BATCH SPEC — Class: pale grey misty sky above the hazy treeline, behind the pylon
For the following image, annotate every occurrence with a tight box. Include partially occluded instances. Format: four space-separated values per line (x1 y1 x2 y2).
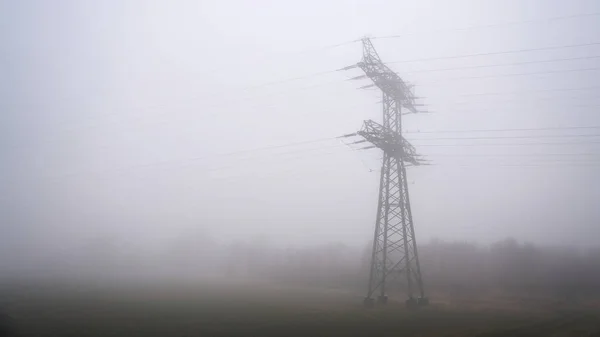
0 0 600 264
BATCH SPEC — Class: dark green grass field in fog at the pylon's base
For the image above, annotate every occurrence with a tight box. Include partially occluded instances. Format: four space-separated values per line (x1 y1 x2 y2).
0 284 600 337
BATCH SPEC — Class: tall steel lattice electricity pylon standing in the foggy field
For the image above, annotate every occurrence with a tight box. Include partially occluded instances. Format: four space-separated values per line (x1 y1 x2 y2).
340 38 428 307
